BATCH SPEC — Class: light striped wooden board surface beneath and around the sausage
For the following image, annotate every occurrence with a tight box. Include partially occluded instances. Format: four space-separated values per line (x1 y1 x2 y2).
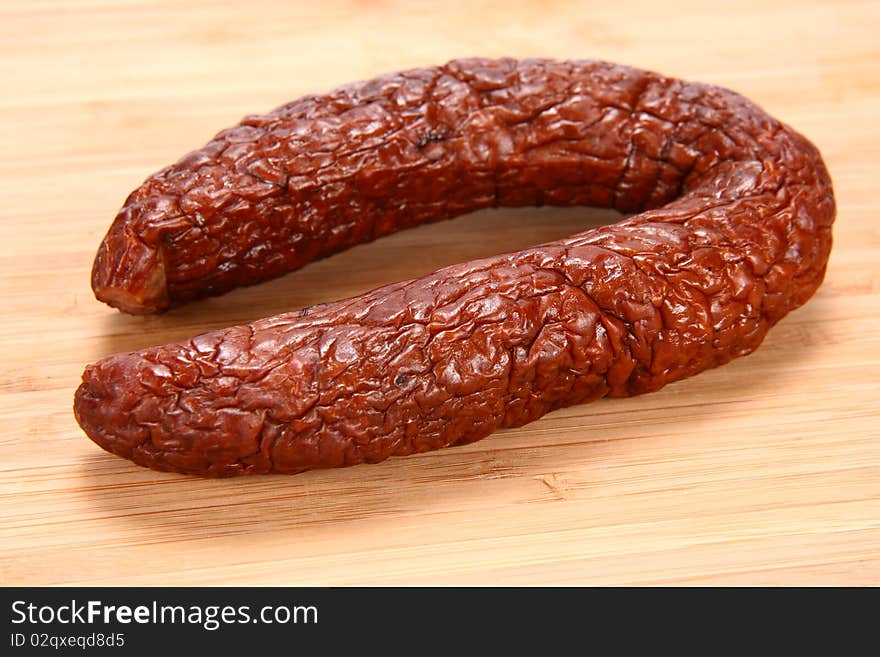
0 0 880 585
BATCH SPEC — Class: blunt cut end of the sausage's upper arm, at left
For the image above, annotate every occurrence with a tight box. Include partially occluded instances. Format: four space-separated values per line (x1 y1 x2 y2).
92 226 171 315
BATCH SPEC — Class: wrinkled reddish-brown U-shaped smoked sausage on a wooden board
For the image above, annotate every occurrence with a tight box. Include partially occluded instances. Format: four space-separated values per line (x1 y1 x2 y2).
75 60 835 475
